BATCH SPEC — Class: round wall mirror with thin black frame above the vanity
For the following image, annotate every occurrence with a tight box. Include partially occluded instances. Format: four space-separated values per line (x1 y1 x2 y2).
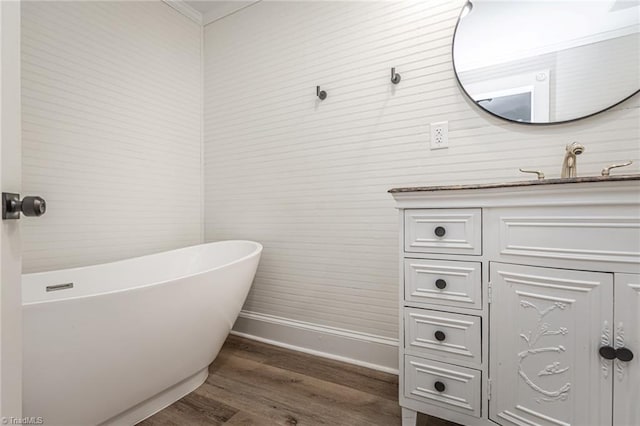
453 0 640 124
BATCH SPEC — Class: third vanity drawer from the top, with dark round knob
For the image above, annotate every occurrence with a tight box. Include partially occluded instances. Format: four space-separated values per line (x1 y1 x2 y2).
404 308 482 367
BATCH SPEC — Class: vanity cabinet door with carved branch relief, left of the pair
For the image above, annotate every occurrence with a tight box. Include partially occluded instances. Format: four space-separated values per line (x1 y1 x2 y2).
489 263 613 426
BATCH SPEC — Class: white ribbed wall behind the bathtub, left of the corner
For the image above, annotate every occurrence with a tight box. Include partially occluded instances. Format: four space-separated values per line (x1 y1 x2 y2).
22 1 202 272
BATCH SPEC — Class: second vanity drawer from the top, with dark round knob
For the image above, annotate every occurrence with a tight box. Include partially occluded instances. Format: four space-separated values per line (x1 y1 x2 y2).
404 259 482 309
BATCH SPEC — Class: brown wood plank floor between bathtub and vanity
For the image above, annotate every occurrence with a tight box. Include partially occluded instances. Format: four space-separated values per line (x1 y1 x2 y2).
139 336 455 426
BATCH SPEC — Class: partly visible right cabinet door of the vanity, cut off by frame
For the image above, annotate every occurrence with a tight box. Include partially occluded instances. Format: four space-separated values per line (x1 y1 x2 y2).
613 274 640 426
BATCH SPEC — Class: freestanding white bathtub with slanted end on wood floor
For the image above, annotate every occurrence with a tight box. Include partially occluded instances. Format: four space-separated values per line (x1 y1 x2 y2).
22 241 262 426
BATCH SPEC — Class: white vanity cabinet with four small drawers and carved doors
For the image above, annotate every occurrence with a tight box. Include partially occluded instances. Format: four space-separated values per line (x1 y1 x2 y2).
391 176 640 426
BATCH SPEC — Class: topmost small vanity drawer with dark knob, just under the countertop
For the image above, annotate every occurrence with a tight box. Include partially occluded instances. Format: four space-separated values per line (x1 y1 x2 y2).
404 209 482 255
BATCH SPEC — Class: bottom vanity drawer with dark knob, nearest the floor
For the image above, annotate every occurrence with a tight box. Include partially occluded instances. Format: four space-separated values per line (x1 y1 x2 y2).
404 355 482 417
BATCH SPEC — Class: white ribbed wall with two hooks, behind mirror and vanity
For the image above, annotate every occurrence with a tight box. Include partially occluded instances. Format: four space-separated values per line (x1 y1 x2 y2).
204 0 640 352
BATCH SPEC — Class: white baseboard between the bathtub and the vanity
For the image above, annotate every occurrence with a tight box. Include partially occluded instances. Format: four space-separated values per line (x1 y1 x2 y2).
231 311 398 374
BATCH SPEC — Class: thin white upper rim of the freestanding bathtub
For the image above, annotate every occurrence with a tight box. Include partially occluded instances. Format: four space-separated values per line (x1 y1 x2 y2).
20 240 264 309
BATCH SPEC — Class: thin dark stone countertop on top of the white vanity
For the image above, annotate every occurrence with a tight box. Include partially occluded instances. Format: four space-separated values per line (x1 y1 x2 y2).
388 174 640 194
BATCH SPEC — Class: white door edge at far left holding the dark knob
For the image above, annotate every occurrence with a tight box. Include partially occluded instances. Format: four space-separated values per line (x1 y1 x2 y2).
0 1 24 416
